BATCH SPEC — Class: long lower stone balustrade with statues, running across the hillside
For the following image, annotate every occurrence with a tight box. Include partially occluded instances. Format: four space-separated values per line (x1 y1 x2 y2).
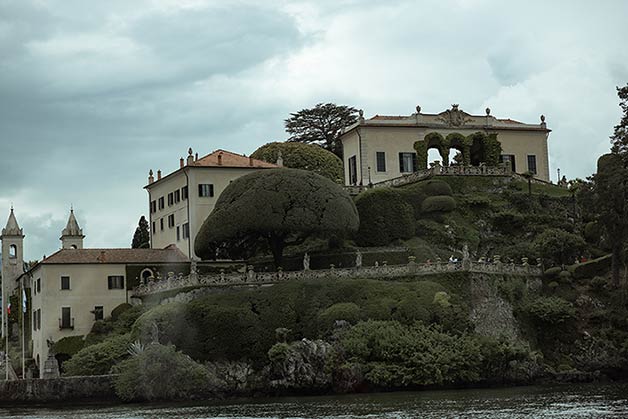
133 257 543 297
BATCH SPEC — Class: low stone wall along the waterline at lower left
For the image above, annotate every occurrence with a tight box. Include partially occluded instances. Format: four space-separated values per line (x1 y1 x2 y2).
0 375 118 404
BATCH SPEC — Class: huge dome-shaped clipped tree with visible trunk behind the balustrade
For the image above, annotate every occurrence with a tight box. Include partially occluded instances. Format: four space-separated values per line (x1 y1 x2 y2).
194 168 359 267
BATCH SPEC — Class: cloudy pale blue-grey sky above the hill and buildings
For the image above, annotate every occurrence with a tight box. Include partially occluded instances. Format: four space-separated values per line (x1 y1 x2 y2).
0 0 628 259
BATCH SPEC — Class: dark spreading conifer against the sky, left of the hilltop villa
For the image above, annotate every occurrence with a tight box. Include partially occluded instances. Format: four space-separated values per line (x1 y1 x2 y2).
284 103 358 158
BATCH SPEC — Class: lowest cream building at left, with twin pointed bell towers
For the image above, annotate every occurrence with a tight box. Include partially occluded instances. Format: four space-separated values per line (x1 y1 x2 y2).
2 211 190 375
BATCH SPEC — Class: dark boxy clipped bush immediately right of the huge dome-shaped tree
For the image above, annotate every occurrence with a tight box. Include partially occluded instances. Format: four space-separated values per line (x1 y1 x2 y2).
355 188 414 246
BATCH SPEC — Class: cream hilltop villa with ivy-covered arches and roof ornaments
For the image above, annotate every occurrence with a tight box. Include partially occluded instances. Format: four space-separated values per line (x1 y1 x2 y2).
341 105 550 185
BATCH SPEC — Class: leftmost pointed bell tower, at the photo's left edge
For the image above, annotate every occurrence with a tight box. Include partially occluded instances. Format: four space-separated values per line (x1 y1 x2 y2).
0 208 24 302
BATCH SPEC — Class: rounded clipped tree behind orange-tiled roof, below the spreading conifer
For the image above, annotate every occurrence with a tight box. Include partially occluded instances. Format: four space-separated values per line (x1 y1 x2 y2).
251 142 344 184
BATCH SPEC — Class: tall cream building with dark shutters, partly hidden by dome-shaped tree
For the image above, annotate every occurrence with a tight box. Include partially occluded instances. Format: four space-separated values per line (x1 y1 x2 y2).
145 149 277 258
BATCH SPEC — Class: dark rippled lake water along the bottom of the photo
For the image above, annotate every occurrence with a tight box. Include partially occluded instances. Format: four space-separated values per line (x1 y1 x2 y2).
0 384 628 419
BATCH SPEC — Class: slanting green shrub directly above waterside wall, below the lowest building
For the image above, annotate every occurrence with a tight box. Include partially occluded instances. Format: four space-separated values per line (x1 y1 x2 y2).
63 334 132 376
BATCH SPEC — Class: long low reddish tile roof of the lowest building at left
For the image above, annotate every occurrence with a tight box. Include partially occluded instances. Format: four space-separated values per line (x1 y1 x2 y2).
40 245 189 265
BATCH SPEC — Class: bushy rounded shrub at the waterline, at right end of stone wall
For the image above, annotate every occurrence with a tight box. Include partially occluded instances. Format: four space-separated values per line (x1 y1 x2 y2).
114 345 212 401
